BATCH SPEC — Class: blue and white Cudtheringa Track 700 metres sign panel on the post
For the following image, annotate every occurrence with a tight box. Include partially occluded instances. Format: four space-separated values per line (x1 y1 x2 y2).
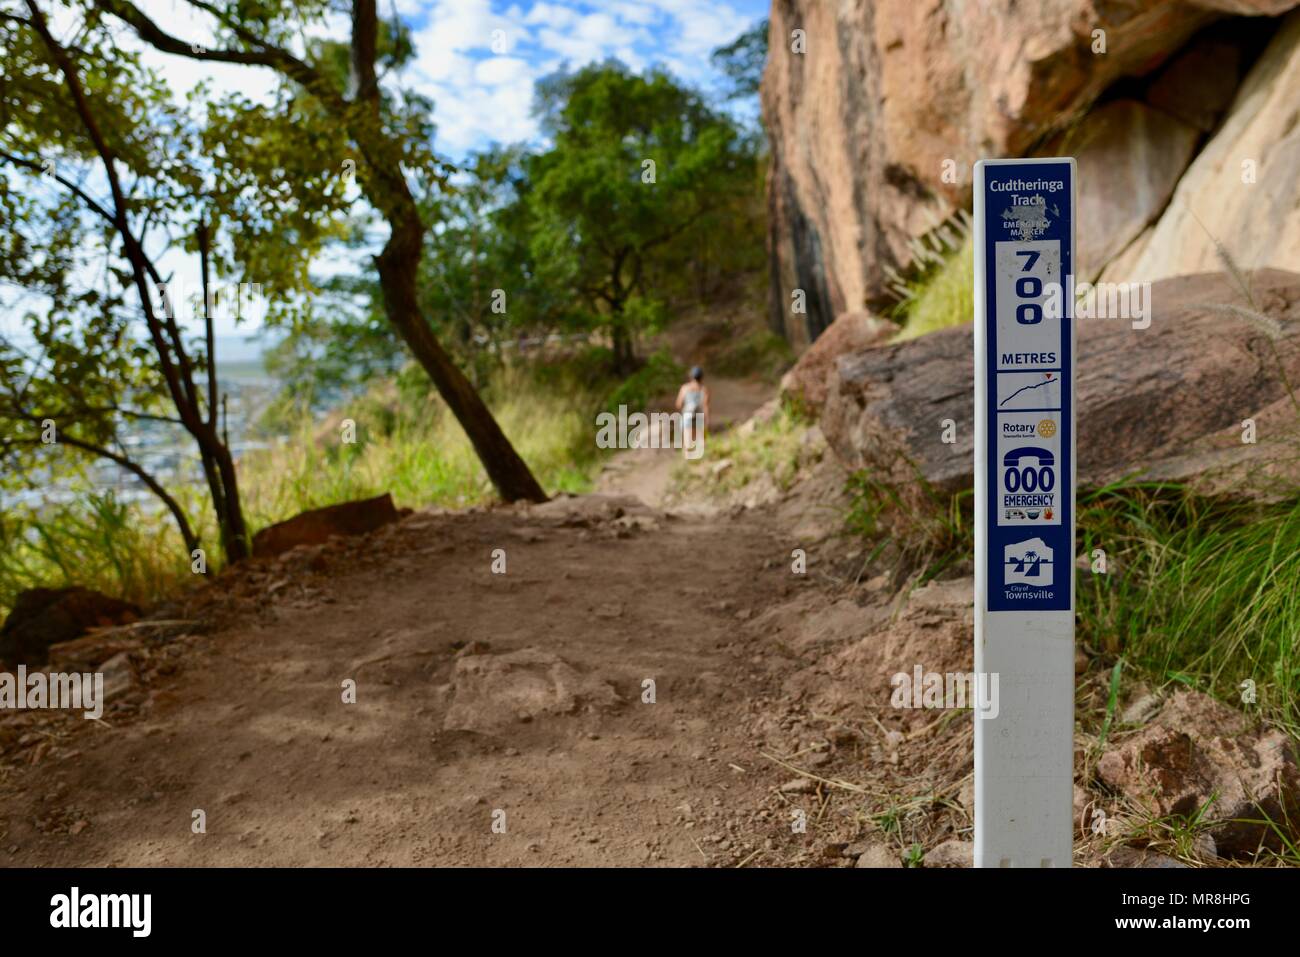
976 160 1074 611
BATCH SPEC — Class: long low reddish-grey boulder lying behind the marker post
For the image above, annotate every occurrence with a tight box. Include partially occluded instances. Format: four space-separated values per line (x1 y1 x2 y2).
822 270 1300 495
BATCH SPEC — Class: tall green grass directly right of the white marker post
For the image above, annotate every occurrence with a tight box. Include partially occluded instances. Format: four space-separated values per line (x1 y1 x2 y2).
1078 485 1300 733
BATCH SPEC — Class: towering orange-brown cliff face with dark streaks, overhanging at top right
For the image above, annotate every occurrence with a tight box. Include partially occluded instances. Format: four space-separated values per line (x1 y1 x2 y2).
762 0 1296 347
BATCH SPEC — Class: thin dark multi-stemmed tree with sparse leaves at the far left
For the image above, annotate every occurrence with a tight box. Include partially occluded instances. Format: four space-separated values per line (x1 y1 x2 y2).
0 0 287 560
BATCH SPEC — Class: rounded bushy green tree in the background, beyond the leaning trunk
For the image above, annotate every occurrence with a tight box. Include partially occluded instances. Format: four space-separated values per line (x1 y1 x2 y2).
528 61 755 373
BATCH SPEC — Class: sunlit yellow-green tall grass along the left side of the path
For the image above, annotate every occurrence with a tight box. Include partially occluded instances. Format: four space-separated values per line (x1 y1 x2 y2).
0 355 618 618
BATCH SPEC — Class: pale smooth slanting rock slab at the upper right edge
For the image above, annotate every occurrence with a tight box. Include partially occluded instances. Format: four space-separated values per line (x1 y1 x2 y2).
1123 13 1300 281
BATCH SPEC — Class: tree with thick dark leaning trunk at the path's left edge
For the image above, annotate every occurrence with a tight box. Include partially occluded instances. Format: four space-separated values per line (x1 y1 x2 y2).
91 0 546 501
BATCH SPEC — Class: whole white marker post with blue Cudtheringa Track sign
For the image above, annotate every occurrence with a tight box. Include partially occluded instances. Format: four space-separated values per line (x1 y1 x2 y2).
975 159 1075 867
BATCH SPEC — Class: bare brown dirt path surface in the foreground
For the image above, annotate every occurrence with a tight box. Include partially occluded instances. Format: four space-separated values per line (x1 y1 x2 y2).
0 486 826 866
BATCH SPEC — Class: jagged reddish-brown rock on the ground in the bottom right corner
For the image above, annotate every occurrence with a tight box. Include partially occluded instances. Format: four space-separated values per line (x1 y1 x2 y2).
1097 690 1300 857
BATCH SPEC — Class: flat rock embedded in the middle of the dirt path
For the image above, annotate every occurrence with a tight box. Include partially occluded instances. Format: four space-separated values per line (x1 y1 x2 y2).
443 648 621 733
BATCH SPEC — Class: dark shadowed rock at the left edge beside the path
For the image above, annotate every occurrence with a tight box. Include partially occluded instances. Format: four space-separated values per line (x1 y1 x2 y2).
0 585 140 666
